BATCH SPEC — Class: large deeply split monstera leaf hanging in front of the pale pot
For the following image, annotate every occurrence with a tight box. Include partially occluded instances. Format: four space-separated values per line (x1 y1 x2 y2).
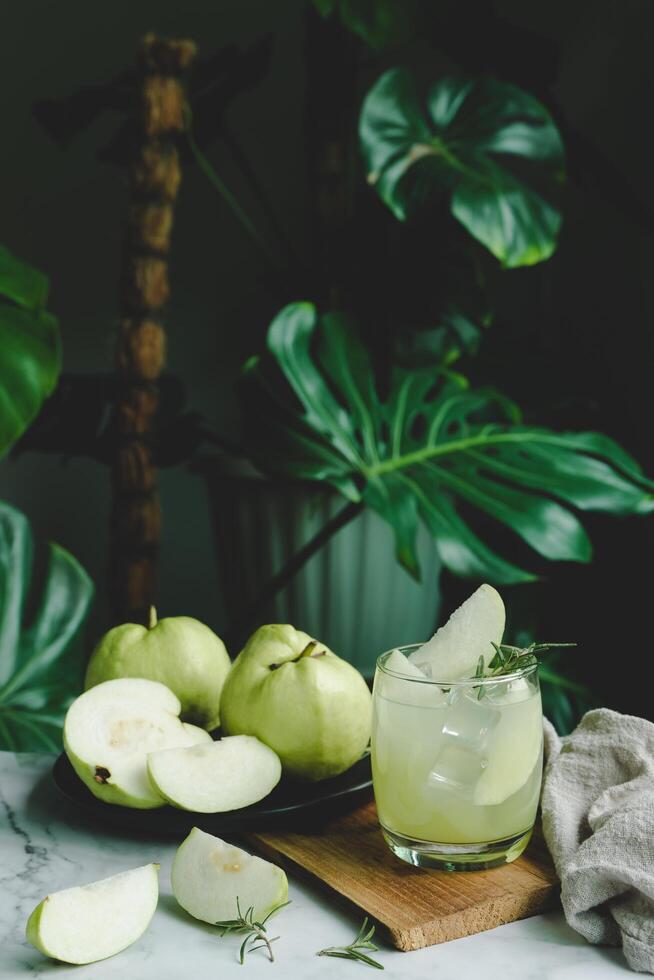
243 303 654 584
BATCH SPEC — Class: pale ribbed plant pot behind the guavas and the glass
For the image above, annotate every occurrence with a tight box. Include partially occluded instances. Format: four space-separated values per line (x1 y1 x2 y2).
197 457 441 675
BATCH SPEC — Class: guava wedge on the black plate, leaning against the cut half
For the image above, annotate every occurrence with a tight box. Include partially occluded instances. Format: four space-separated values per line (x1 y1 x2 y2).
148 735 282 813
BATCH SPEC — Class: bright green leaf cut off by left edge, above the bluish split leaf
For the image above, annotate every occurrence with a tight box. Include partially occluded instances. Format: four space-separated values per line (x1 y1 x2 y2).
0 246 61 456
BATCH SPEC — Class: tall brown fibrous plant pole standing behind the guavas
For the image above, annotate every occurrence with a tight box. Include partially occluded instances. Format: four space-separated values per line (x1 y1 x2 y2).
109 34 196 623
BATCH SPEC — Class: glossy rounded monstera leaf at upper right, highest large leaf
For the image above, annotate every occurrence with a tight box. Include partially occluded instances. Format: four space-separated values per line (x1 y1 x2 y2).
359 68 564 267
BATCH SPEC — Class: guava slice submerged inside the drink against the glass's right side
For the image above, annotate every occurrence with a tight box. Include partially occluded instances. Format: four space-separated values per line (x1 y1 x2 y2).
472 681 543 806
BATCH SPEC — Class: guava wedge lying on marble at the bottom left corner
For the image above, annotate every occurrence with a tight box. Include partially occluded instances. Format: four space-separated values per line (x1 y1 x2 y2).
26 864 159 964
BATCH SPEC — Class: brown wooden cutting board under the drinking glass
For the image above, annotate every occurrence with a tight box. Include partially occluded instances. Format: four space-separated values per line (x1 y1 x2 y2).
247 803 559 950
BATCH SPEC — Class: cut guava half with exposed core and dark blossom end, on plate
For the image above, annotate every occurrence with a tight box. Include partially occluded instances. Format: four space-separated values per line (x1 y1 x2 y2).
64 677 200 809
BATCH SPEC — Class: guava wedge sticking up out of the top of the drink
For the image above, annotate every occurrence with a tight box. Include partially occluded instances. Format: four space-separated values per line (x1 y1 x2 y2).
409 585 506 682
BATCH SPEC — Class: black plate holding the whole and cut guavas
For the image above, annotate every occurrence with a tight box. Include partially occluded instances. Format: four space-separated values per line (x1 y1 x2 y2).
52 752 372 837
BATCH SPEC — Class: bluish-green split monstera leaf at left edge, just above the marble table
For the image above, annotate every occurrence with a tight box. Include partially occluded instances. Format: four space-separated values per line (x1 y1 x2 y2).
0 503 93 752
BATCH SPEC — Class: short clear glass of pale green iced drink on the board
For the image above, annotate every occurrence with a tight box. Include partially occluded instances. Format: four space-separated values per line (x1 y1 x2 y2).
372 643 543 871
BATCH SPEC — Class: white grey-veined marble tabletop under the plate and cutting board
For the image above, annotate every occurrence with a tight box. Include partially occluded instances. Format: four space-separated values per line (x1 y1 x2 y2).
0 752 633 980
